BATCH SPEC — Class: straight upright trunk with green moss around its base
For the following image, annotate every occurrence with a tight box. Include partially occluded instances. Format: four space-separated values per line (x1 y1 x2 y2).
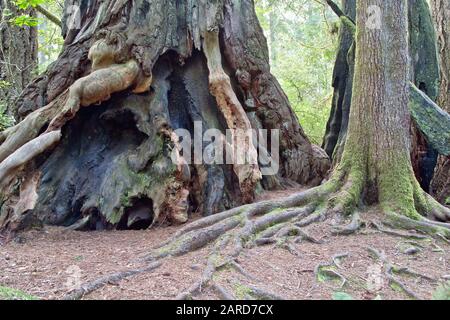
338 0 418 218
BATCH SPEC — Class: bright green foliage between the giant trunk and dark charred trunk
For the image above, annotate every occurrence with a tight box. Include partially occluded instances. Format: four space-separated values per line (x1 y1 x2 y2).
255 0 338 145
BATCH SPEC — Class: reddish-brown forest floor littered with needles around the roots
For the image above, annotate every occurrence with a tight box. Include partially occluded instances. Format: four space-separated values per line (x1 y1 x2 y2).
0 189 450 300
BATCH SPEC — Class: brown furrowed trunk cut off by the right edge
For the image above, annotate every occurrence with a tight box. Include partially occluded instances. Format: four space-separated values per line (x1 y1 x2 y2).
431 0 450 205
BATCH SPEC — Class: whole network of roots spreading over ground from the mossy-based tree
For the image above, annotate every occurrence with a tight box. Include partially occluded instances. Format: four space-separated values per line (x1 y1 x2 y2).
53 175 450 299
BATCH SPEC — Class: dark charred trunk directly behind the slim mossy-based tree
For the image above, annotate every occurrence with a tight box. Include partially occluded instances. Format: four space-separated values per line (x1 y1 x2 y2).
323 0 439 190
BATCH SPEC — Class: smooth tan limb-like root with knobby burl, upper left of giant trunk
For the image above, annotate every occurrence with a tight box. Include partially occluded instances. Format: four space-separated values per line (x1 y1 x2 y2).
0 33 150 181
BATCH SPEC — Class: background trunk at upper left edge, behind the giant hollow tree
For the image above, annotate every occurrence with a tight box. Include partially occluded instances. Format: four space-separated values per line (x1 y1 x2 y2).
0 0 38 113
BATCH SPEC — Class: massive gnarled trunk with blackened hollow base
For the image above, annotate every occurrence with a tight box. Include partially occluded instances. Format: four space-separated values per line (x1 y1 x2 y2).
0 0 329 229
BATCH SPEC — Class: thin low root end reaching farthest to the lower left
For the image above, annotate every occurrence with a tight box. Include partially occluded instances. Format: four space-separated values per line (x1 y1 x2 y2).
63 262 162 300
